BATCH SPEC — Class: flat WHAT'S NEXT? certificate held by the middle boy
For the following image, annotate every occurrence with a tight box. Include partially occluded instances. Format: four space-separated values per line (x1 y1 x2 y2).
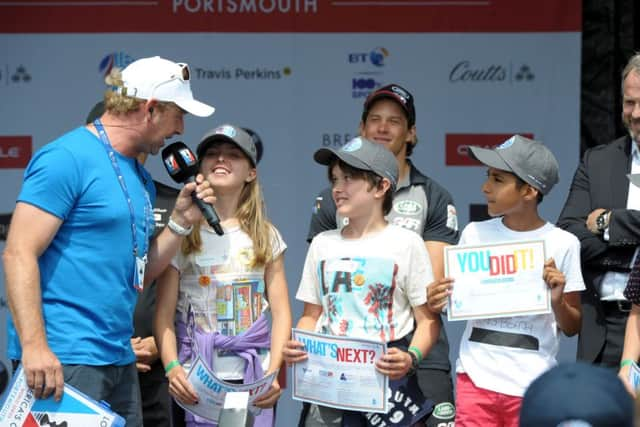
292 328 389 414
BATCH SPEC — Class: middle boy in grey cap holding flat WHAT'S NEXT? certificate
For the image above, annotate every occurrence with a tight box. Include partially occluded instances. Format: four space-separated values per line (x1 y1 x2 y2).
284 138 440 426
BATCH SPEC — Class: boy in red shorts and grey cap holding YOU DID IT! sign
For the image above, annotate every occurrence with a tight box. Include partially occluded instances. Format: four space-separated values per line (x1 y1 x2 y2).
429 135 585 427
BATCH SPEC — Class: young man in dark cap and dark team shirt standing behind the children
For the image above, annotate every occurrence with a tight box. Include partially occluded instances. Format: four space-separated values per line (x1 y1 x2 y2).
307 83 460 427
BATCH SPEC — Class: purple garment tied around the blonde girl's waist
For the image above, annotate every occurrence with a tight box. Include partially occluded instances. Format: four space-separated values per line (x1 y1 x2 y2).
176 314 274 427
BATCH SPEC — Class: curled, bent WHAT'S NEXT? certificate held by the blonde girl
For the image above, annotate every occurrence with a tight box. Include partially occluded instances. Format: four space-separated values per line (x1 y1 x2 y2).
176 357 278 423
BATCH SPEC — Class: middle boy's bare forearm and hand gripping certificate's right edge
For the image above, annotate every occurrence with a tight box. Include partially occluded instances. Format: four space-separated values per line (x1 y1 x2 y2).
376 304 440 380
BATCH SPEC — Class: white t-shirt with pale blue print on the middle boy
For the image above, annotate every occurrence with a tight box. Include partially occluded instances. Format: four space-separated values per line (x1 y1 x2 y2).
296 225 433 342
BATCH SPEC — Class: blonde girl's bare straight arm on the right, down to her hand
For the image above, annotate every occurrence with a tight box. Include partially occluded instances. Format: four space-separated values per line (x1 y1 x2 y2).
254 254 291 408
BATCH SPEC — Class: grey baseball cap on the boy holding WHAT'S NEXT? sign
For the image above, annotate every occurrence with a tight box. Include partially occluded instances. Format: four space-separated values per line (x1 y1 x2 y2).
313 137 398 191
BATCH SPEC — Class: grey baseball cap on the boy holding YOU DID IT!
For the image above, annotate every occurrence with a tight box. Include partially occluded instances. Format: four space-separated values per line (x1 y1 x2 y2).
469 135 559 194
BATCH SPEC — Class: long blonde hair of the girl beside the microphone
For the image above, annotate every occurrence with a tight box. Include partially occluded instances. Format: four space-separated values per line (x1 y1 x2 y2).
182 167 273 268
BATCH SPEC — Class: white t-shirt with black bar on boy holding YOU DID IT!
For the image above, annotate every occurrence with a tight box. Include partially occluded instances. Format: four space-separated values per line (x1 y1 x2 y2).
453 218 585 396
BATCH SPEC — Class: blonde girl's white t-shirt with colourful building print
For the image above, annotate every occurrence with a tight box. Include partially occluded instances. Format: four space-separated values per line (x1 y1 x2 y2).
171 226 287 380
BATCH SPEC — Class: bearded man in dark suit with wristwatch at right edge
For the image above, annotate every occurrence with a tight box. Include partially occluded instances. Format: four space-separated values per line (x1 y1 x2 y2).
558 54 640 369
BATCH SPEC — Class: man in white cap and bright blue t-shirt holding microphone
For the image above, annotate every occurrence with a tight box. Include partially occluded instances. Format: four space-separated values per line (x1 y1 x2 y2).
4 57 215 426
